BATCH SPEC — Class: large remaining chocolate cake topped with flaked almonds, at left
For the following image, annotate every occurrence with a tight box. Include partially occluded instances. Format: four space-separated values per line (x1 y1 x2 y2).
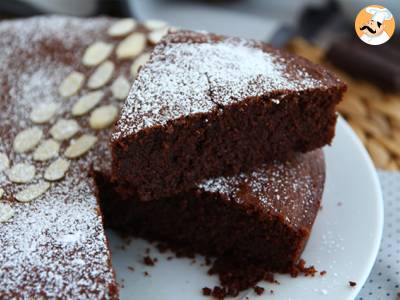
0 16 158 299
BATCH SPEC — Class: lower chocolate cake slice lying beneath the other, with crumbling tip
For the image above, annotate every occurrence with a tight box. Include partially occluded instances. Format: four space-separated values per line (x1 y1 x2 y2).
96 150 325 295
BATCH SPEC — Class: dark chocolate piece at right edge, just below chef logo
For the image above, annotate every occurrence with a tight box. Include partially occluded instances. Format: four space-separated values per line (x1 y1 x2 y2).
326 38 400 91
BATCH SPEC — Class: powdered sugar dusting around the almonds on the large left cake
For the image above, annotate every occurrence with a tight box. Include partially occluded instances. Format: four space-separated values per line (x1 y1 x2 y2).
0 17 144 299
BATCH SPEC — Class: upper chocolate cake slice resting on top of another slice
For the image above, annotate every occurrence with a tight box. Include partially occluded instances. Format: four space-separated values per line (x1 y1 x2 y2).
112 31 345 201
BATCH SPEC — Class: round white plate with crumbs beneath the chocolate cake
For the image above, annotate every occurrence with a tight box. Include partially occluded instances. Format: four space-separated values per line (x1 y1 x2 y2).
109 119 383 300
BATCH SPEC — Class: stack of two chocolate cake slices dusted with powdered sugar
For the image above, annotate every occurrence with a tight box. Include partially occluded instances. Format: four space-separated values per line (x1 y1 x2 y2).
107 31 345 295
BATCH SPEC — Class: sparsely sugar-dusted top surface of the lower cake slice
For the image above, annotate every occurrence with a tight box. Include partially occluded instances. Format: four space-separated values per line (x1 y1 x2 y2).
199 150 325 228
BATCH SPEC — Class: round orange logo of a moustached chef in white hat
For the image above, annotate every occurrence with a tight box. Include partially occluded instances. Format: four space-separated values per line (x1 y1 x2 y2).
355 5 395 45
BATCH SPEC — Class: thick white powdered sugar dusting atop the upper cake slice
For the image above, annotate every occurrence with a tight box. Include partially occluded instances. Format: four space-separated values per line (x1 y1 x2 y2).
113 32 321 139
